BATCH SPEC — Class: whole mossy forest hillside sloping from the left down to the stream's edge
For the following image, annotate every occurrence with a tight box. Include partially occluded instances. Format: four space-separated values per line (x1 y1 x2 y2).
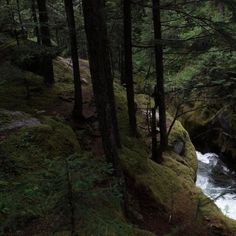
0 42 236 236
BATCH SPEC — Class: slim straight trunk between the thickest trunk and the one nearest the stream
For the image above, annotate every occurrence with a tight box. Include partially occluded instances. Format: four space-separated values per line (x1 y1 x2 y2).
123 0 137 136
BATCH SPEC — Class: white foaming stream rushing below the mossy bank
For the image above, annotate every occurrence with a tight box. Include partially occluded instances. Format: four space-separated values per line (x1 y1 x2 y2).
196 152 236 220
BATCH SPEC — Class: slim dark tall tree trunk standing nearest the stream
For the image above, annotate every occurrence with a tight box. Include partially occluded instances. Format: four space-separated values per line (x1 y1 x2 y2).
152 0 168 158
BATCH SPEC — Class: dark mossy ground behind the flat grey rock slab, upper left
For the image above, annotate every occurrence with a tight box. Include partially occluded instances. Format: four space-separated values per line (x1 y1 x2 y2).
0 60 73 114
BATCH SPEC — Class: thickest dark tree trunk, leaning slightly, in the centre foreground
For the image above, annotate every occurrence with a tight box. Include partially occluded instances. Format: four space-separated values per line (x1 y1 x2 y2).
83 0 119 172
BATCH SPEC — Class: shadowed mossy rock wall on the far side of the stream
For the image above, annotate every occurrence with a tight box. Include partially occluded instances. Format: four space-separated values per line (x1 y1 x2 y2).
181 101 236 166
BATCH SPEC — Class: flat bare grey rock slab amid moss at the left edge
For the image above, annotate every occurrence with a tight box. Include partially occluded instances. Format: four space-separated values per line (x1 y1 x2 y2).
0 110 41 132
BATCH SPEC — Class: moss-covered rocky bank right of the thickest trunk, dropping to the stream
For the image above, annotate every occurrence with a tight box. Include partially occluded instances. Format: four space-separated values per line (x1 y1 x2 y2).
116 85 236 235
